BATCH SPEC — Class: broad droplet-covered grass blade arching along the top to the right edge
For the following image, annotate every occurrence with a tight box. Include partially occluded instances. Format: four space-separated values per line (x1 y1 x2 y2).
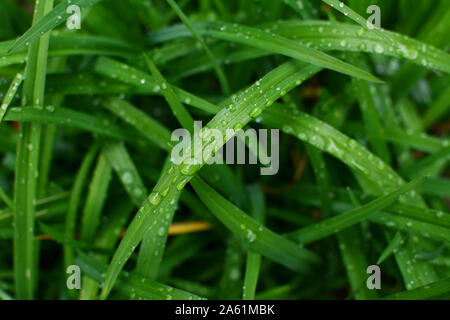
151 20 450 73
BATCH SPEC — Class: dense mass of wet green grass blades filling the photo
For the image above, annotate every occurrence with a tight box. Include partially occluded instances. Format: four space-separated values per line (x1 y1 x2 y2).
0 0 450 300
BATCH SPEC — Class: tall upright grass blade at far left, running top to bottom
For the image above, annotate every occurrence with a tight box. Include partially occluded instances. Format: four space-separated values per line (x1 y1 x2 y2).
14 0 53 299
